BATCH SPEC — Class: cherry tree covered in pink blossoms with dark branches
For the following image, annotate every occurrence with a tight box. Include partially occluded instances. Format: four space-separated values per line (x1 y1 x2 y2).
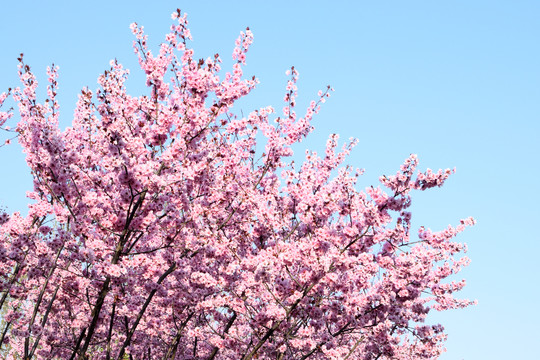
0 10 474 360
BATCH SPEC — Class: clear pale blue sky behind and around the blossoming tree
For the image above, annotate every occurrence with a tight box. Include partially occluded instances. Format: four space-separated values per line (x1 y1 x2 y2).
0 0 540 360
